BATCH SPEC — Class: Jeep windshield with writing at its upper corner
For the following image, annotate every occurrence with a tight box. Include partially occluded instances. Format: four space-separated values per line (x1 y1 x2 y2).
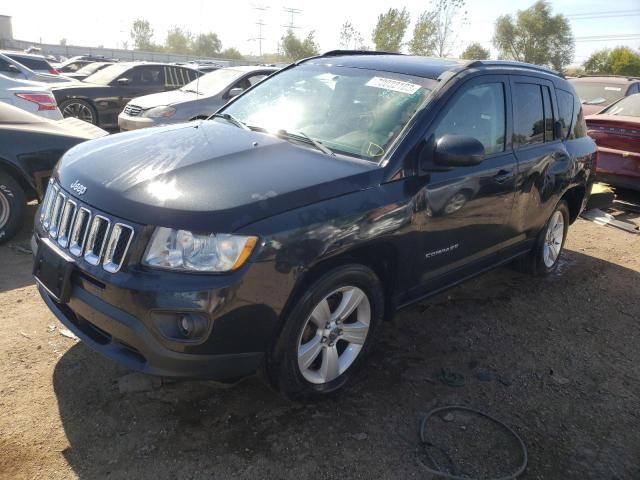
223 65 435 162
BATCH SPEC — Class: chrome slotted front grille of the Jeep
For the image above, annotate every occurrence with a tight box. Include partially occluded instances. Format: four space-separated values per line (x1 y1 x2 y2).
40 181 134 273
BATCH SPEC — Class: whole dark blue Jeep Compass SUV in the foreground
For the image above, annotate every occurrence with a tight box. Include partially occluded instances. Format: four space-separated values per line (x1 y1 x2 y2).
34 51 596 396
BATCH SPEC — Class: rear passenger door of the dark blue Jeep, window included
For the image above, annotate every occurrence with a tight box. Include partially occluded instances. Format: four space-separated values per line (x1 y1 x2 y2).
508 76 572 249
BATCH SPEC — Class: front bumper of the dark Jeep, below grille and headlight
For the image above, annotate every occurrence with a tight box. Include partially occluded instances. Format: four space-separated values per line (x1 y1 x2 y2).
32 222 279 380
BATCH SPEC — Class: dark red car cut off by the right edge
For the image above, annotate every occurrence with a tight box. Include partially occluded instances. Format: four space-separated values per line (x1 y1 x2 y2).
586 94 640 191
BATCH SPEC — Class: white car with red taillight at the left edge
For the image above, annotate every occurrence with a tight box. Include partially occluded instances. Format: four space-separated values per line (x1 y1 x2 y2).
0 74 63 120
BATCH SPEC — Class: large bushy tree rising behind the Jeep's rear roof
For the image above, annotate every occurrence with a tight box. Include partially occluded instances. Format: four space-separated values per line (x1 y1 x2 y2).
493 0 575 71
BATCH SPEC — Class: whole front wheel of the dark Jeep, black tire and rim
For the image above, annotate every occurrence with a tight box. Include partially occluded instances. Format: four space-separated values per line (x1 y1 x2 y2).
266 264 384 398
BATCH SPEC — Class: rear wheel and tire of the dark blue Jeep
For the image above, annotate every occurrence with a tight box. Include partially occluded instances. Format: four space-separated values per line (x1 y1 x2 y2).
516 200 570 276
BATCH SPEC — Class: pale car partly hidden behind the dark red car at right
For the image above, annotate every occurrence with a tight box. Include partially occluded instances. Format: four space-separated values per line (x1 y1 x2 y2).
569 75 640 115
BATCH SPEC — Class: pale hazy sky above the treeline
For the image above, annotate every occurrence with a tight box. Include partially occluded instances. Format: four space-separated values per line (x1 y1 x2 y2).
0 0 640 64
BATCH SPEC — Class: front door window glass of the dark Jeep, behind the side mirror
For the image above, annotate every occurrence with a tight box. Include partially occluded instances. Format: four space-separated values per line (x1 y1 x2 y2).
435 83 506 155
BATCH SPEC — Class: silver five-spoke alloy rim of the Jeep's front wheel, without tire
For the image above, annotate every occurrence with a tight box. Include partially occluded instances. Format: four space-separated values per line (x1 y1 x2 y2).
298 286 371 384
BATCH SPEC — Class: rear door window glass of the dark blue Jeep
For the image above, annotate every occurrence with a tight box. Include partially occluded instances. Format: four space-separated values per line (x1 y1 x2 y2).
513 83 545 147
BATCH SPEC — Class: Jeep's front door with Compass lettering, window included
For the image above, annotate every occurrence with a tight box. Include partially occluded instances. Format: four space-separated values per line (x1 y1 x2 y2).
410 75 517 297
